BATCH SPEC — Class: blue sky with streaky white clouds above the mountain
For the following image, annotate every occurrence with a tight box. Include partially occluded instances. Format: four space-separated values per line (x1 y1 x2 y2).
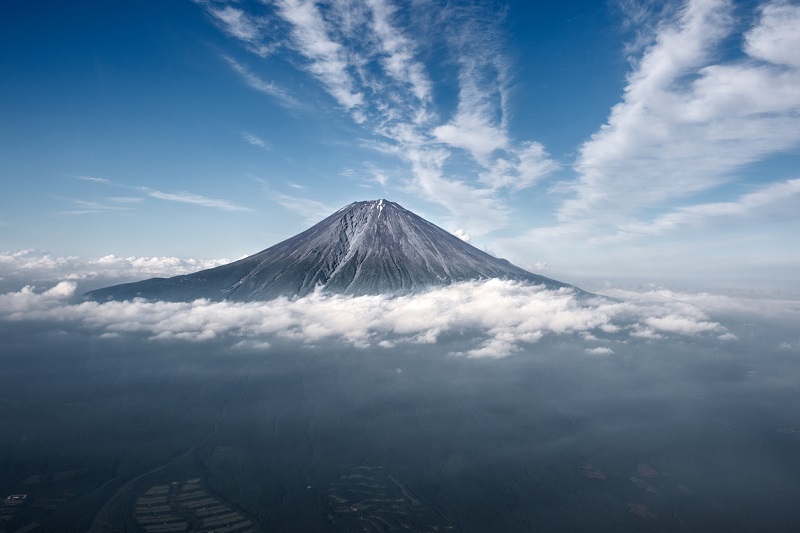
0 0 800 289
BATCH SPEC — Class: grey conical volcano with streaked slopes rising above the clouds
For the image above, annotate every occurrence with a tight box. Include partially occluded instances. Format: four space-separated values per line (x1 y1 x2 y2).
87 200 571 301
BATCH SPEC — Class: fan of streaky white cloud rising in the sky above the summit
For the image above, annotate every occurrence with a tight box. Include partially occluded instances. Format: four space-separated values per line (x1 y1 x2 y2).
200 0 559 235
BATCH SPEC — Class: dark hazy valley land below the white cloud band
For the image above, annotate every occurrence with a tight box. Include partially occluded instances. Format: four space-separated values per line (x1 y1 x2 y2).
0 316 800 532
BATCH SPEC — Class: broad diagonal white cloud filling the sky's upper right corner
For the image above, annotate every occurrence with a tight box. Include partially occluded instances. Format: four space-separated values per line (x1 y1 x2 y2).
558 0 800 233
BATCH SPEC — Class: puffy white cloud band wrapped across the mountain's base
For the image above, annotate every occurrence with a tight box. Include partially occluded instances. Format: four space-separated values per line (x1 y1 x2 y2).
0 280 748 357
